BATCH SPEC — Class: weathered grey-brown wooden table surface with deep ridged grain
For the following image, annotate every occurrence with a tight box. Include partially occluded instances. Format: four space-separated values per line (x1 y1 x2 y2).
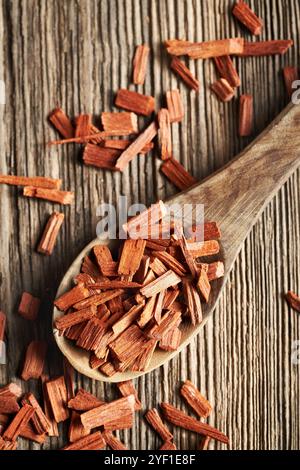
0 0 300 449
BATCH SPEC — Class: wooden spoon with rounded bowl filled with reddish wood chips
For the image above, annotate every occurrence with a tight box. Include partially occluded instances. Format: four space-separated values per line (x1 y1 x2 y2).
53 104 300 382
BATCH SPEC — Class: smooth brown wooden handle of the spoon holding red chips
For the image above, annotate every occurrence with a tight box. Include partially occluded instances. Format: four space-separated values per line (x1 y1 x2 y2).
167 104 300 270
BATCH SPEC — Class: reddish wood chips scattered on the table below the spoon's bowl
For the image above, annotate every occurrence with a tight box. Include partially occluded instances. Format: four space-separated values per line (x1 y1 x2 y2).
0 376 229 450
